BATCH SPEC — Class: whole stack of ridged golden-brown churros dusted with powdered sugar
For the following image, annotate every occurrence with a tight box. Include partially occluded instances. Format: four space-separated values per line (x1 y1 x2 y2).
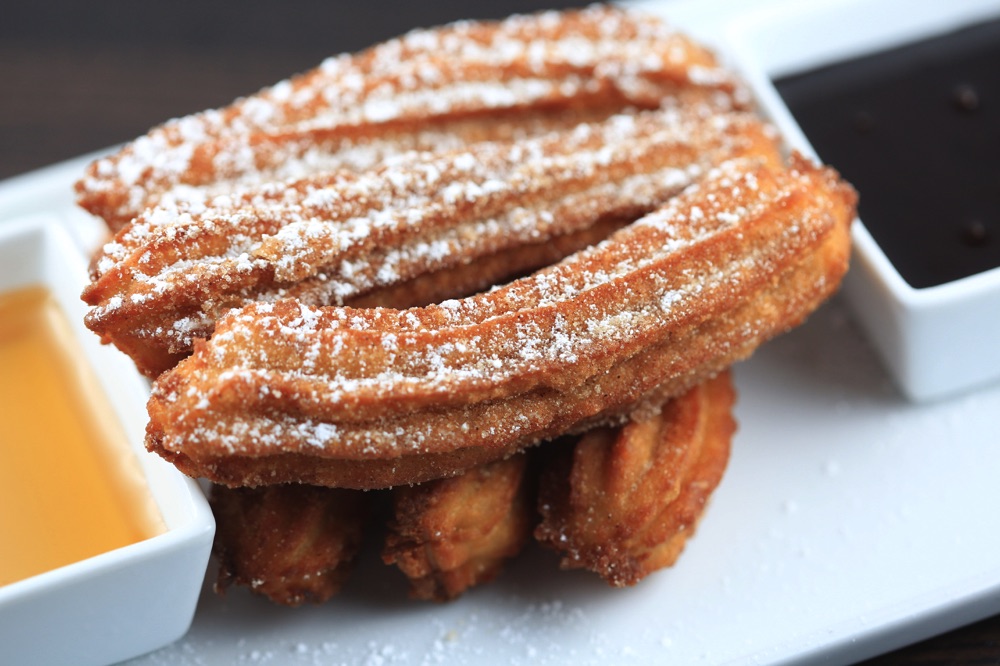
77 7 855 605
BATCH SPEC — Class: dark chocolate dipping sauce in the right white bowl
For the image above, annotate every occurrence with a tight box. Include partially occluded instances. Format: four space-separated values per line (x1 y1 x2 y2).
775 20 1000 289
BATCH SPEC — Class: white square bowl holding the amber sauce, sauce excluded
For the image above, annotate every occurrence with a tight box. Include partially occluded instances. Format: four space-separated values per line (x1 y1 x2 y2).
0 217 215 665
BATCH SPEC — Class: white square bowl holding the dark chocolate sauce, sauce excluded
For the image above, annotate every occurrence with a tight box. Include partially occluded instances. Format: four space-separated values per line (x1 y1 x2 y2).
717 0 1000 401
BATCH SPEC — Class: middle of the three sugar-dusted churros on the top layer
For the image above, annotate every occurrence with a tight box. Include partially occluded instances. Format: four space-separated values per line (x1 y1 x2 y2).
83 109 778 377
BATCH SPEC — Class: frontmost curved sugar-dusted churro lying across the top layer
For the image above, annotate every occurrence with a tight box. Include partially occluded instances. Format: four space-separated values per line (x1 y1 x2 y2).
147 158 854 487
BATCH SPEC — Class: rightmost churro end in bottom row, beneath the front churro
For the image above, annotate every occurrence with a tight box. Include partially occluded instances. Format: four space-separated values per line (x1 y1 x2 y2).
535 373 736 587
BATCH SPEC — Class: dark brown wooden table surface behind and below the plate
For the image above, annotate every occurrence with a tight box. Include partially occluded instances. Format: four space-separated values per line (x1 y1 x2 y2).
0 0 1000 666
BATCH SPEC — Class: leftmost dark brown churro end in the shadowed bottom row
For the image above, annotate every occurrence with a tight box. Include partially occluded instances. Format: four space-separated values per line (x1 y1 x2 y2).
210 484 367 606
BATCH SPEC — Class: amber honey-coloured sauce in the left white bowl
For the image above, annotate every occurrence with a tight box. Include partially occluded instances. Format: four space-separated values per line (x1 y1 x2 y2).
0 287 164 585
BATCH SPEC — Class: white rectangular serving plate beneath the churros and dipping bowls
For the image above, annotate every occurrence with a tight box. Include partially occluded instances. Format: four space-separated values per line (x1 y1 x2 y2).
0 1 1000 666
